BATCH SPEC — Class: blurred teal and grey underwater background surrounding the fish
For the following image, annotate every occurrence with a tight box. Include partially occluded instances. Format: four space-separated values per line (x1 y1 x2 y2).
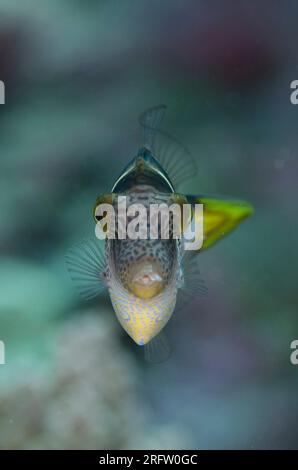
0 0 298 449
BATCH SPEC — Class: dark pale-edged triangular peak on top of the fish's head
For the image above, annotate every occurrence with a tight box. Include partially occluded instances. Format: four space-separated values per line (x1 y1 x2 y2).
112 147 174 192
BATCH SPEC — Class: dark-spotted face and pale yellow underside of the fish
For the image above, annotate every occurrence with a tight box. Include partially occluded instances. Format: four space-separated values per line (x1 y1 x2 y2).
106 185 180 345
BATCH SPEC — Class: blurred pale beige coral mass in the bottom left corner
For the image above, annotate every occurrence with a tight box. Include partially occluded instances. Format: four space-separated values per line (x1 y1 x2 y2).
0 311 181 449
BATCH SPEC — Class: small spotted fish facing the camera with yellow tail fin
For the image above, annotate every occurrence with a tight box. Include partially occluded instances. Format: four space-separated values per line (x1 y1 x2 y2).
66 105 254 362
